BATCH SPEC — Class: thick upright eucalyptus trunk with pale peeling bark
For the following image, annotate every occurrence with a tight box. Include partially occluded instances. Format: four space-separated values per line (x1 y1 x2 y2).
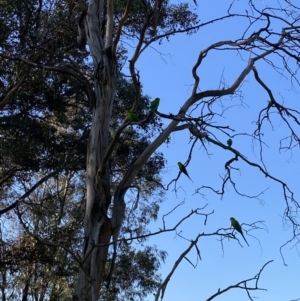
74 0 116 301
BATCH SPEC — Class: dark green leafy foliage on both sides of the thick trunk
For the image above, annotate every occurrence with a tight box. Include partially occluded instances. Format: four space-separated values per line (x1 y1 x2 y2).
0 0 202 301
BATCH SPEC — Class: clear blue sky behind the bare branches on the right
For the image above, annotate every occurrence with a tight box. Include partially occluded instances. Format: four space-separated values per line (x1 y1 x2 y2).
122 1 300 301
